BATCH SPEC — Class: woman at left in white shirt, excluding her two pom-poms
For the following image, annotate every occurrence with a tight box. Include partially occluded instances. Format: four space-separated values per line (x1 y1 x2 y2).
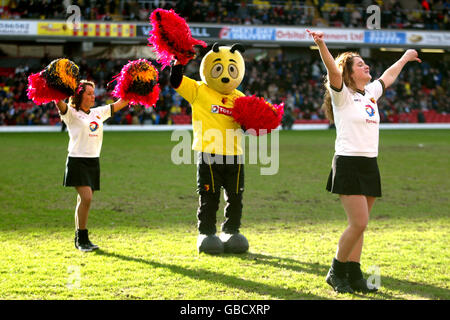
56 80 128 251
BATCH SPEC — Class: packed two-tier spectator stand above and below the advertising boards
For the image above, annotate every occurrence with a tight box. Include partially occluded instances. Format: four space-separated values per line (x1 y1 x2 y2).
0 0 450 125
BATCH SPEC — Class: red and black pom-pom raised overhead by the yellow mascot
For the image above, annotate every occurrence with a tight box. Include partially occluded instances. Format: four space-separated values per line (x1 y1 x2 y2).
148 9 206 69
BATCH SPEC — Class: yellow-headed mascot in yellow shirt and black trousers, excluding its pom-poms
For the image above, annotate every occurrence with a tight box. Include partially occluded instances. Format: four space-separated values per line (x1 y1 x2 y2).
170 44 249 254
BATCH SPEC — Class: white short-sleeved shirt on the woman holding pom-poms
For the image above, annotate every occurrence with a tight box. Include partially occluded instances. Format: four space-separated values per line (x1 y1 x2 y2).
60 105 113 158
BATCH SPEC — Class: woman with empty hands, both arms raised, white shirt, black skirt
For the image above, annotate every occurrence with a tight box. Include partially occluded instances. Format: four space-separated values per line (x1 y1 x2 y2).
307 30 421 293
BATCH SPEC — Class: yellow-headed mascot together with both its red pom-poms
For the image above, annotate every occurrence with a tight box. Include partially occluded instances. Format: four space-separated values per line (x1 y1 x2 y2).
148 9 283 254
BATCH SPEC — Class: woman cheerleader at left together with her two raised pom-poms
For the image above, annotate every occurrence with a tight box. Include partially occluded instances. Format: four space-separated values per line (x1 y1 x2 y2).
27 58 160 251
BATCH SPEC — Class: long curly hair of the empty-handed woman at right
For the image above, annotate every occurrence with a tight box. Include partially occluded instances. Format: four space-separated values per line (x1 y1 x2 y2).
322 51 361 123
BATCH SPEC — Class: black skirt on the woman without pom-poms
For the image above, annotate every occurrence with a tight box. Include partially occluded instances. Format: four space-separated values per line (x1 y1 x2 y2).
326 155 381 197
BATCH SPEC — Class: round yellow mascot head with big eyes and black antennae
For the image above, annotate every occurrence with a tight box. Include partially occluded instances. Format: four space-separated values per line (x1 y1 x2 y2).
200 42 245 94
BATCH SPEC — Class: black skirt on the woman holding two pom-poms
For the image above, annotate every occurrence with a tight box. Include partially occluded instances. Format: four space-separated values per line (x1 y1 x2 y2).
63 157 100 190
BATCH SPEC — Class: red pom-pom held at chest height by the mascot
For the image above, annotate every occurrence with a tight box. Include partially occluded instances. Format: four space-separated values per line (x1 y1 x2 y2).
231 96 284 136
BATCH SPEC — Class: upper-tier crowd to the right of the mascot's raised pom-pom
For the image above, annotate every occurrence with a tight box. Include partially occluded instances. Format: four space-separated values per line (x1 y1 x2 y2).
160 0 450 30
